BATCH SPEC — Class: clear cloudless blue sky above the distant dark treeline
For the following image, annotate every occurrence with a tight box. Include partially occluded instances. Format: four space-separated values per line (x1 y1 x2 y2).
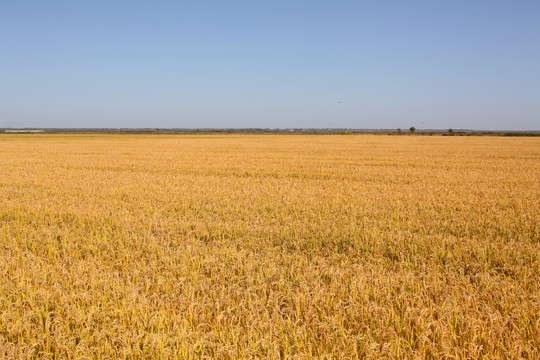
0 0 540 130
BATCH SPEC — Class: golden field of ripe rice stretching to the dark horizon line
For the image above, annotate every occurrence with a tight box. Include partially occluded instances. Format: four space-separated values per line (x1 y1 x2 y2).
0 134 540 359
